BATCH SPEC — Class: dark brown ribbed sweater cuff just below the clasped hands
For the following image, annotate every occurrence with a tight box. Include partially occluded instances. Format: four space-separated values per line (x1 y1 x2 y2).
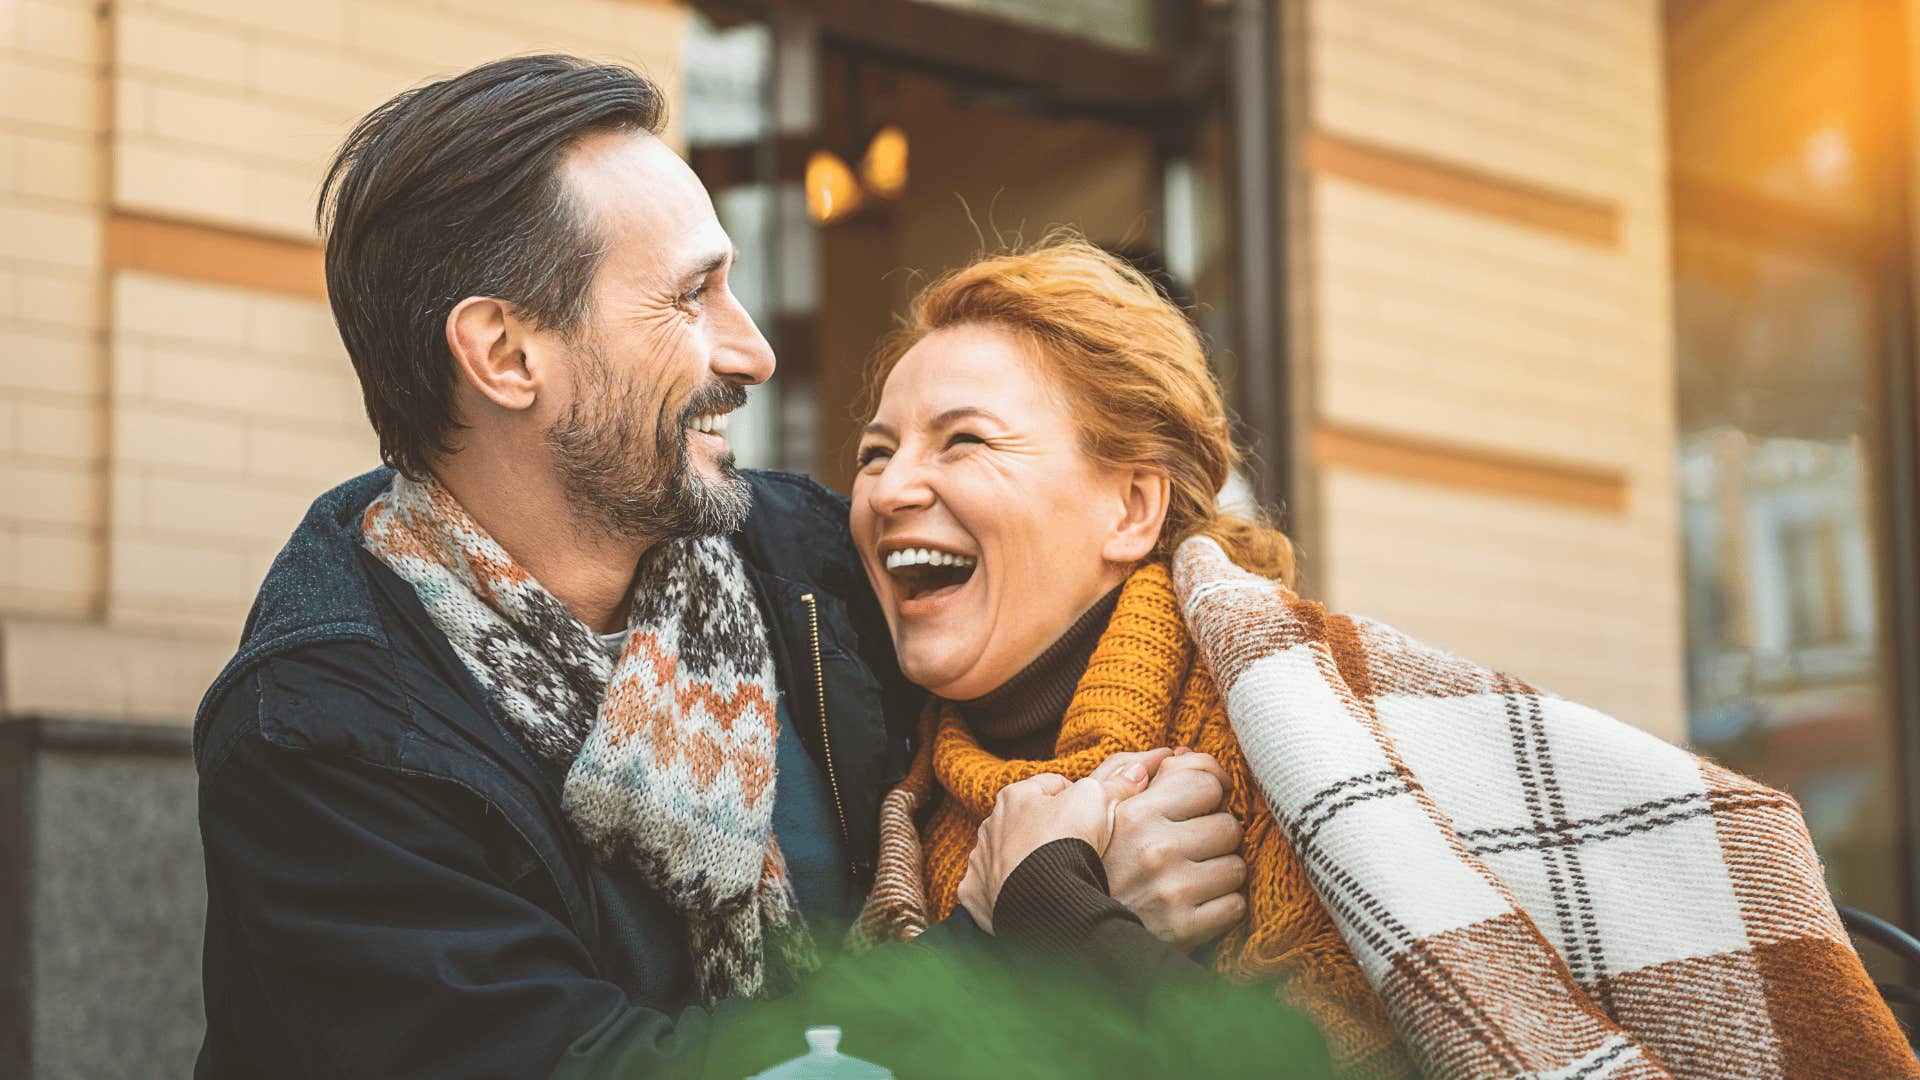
993 838 1139 949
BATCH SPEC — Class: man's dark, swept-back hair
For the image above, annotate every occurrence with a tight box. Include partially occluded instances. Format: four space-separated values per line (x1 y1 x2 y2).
317 56 666 477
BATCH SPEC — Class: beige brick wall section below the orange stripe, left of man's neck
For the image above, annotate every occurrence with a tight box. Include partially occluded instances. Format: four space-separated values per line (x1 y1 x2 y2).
108 273 378 638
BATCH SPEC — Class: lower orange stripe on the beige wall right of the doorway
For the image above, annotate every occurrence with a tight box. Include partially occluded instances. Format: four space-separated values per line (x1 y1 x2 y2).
1313 425 1628 513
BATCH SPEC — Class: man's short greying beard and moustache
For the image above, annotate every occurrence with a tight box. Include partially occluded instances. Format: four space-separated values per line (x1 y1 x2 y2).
547 346 753 542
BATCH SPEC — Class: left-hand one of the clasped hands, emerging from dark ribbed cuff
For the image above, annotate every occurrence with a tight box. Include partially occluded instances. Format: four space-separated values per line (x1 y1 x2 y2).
960 749 1173 934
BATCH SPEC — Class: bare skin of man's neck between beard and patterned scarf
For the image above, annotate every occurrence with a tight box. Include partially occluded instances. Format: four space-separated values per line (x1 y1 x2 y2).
436 454 653 634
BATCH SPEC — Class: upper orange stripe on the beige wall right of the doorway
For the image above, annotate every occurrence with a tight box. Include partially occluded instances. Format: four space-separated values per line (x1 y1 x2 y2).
1304 131 1620 248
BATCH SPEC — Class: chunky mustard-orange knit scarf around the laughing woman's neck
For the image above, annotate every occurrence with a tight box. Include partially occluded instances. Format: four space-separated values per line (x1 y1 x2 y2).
860 563 1411 1078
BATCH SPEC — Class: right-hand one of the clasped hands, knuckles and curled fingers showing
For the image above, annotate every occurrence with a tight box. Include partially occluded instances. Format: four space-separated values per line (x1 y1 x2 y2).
1094 751 1246 949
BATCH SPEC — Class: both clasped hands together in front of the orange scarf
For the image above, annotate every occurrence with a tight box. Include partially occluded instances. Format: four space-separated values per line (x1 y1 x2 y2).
960 748 1246 949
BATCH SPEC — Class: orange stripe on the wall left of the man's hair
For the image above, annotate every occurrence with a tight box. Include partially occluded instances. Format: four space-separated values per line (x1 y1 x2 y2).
106 211 326 300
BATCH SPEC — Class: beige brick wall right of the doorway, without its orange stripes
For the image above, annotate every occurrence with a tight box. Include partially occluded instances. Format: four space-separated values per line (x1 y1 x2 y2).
1294 0 1684 738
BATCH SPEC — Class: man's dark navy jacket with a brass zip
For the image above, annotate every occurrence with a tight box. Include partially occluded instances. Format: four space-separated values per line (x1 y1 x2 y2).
194 469 918 1078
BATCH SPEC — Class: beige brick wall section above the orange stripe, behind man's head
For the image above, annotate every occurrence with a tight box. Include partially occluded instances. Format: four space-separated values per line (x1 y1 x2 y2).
111 0 685 238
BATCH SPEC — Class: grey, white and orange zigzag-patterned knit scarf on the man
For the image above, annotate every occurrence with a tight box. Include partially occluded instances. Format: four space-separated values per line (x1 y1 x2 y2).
361 477 812 1005
